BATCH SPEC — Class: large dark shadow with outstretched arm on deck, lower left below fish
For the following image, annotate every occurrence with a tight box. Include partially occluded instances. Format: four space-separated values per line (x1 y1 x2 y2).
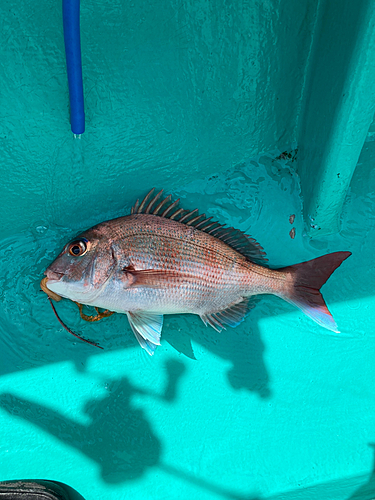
0 361 184 483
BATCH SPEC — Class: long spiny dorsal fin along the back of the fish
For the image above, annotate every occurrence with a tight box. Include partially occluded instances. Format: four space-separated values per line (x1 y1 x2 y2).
131 188 268 265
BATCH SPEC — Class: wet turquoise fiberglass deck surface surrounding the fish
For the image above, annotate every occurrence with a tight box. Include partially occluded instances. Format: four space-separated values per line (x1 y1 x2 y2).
0 1 375 500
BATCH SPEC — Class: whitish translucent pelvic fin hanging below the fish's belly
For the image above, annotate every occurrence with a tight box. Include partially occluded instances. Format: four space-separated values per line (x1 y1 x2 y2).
127 311 163 356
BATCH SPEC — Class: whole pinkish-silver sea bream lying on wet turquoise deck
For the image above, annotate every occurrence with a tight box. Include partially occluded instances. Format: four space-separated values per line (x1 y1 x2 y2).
44 188 351 355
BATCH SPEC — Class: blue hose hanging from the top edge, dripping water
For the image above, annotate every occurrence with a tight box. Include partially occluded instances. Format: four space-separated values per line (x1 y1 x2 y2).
62 0 85 136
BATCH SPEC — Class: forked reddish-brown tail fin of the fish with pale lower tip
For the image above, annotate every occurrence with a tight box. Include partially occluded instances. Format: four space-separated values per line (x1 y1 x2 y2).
281 252 351 333
